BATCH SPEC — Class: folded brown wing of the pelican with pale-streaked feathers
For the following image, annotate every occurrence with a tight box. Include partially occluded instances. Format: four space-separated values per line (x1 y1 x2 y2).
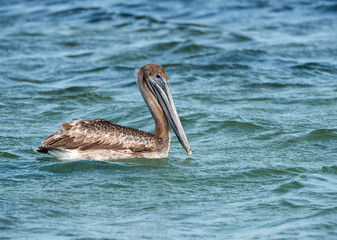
36 119 161 153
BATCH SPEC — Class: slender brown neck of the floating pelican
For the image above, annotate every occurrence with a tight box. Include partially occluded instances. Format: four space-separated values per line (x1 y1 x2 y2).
137 76 170 140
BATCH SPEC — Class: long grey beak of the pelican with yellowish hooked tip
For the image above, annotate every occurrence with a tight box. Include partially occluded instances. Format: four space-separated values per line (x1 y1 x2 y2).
147 77 192 156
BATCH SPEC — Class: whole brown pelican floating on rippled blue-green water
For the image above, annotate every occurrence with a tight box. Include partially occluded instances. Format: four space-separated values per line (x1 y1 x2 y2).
36 64 192 160
